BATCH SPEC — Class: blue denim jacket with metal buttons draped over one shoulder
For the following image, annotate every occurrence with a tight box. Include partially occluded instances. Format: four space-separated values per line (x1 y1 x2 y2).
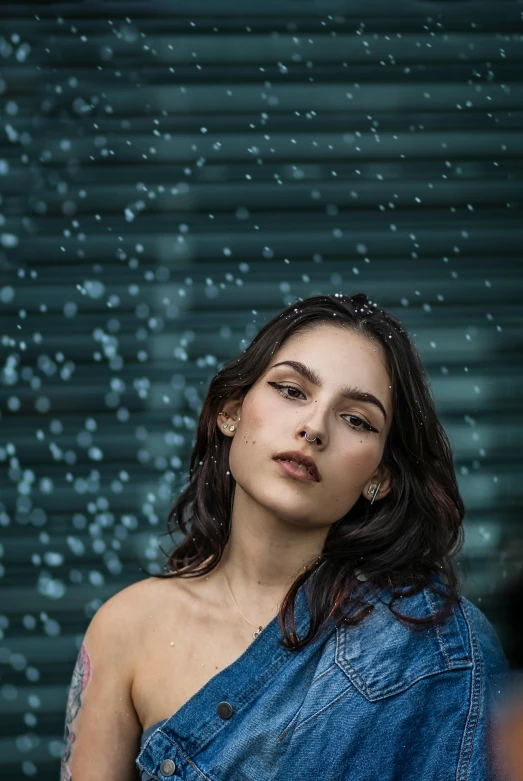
136 572 509 781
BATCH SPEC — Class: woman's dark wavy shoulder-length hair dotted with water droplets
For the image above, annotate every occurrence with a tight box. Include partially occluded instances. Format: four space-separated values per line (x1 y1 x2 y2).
140 293 465 650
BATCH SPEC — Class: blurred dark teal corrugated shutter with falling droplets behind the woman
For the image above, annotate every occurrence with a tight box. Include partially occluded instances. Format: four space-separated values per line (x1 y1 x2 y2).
0 0 523 781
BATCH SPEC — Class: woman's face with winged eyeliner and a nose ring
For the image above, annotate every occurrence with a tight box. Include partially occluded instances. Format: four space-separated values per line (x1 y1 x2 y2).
224 324 392 527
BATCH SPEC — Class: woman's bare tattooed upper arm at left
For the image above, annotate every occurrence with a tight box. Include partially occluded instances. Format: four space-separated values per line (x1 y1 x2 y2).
60 589 142 781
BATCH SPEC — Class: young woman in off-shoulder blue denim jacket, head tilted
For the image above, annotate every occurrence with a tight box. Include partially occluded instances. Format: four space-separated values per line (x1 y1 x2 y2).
62 294 508 781
